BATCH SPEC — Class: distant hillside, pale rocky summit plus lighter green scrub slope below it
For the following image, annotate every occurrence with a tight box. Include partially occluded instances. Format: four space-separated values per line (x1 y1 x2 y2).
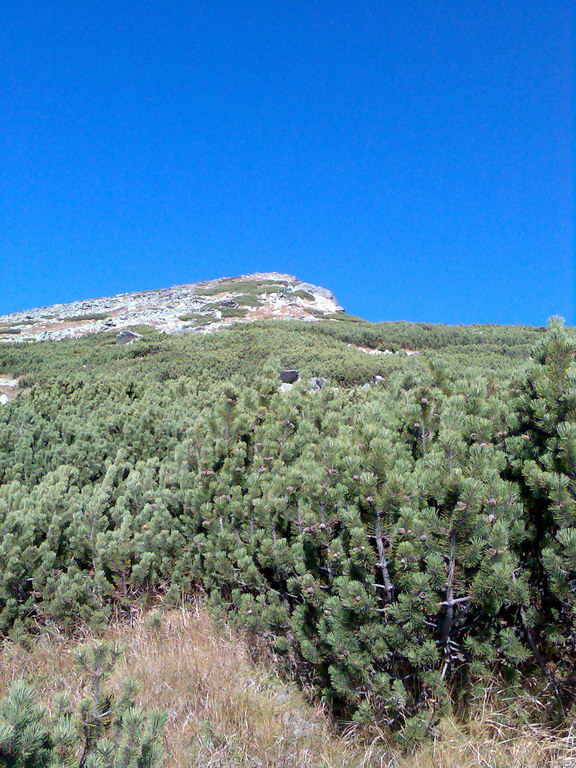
0 273 545 405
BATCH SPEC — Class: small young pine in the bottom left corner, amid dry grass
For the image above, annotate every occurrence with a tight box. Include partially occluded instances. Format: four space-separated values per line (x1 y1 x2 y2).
0 643 166 768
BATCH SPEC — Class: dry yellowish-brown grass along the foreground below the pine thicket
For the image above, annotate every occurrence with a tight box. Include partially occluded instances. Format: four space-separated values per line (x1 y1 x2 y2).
0 606 576 768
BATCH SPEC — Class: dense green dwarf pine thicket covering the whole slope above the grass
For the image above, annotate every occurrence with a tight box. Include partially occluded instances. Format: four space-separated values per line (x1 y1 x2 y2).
0 319 576 743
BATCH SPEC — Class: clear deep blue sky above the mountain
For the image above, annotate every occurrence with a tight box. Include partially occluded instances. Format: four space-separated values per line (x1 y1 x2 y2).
0 0 575 324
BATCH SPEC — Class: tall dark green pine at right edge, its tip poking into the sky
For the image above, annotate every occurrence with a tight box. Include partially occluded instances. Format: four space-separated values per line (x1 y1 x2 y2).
508 319 576 703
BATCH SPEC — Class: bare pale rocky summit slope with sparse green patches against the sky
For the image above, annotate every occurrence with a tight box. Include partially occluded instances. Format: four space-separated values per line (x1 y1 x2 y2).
0 272 343 344
